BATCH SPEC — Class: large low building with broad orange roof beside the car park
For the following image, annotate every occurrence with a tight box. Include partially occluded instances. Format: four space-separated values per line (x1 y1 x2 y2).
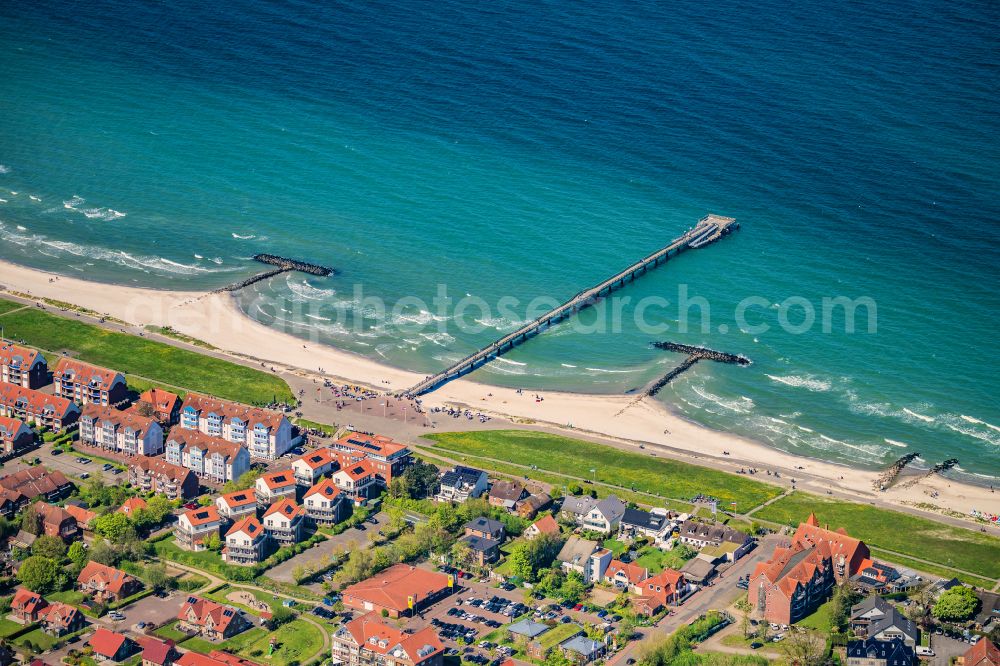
341 564 453 618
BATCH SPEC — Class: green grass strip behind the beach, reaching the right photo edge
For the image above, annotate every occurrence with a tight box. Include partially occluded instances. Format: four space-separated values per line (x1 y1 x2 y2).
754 492 1000 579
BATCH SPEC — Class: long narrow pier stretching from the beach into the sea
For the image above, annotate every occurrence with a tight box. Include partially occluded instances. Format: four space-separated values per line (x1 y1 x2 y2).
405 215 739 397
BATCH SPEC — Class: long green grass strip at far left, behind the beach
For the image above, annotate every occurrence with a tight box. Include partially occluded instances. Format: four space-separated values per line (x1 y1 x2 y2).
0 299 293 404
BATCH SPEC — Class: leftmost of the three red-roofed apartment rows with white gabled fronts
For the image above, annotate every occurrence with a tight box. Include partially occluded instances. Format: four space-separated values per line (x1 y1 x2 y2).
80 402 163 456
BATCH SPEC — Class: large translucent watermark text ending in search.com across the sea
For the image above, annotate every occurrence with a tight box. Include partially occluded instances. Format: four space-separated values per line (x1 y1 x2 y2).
236 284 878 337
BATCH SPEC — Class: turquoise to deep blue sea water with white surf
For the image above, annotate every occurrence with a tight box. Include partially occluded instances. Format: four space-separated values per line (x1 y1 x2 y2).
0 0 1000 483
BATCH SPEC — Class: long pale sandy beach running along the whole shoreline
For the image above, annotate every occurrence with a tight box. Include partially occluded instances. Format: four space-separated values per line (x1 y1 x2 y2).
0 262 1000 515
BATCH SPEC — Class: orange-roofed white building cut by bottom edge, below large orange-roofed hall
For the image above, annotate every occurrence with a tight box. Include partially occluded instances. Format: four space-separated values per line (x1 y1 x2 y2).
332 613 444 666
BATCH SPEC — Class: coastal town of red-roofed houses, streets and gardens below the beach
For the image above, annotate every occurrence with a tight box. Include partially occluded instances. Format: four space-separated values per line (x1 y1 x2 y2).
0 326 1000 666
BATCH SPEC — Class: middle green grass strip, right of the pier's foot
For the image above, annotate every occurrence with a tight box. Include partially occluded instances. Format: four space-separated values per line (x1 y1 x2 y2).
426 430 781 512
